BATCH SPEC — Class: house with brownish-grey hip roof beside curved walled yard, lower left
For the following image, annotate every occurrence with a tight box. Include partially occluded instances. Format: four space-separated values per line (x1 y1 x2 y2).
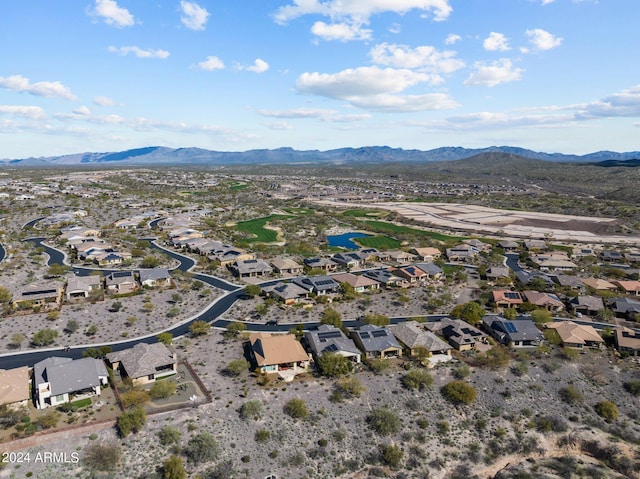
107 343 178 385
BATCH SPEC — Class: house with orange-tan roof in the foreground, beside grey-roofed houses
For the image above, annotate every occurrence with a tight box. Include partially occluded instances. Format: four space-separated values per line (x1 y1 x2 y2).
249 333 311 380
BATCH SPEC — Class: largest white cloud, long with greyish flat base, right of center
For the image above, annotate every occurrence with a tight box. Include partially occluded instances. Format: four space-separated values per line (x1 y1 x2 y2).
296 67 458 112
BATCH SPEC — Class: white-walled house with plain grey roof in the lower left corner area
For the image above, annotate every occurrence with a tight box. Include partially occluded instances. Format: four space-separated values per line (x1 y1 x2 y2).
33 356 109 409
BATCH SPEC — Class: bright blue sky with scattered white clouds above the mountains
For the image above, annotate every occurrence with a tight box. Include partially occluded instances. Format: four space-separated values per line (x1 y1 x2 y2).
0 0 640 158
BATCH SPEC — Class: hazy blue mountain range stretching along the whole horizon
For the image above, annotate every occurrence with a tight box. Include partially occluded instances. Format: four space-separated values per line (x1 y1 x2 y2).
0 146 640 167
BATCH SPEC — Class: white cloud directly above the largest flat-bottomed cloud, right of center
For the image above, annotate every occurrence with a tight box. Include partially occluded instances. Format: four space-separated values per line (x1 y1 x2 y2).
369 43 465 75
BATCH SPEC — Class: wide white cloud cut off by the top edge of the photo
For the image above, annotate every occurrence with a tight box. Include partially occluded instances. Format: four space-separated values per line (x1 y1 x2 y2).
273 0 453 24
